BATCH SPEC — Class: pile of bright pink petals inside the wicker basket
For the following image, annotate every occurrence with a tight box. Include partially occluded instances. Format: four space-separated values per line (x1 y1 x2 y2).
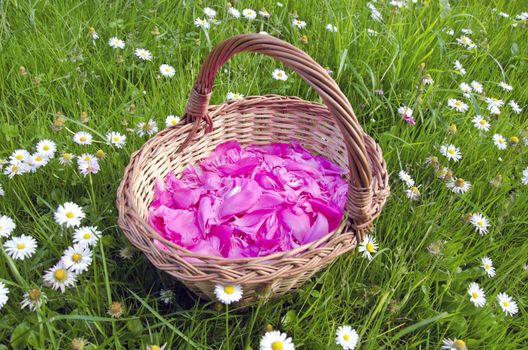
150 141 348 258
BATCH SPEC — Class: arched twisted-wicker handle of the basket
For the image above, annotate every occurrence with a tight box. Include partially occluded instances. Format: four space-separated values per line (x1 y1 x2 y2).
179 34 372 229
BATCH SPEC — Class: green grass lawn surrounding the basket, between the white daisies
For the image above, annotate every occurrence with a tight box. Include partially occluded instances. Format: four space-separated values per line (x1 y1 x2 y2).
0 0 528 349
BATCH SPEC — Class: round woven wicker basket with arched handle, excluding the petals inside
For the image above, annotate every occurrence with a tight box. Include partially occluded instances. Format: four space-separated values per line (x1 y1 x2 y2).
117 34 389 302
